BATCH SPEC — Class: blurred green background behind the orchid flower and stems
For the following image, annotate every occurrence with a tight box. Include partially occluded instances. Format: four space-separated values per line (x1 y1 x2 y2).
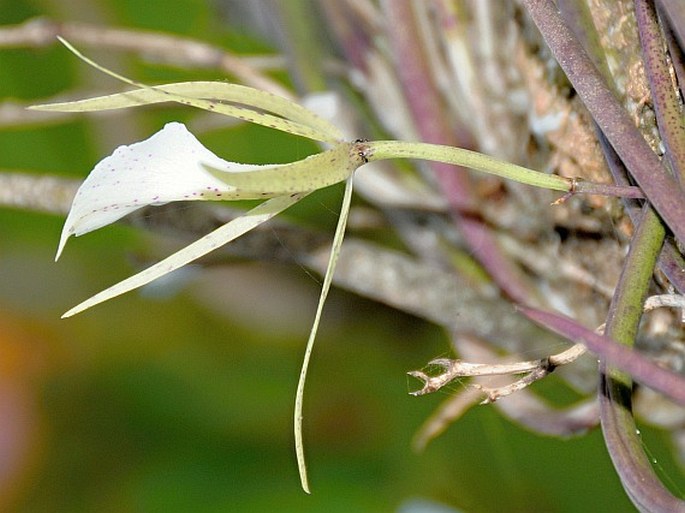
0 0 682 513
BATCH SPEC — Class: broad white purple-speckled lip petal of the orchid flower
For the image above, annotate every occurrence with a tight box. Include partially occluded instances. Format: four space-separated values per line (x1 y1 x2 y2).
56 123 264 258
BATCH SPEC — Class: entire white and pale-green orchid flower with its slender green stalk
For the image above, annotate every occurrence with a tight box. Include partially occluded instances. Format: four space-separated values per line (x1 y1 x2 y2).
33 40 620 493
